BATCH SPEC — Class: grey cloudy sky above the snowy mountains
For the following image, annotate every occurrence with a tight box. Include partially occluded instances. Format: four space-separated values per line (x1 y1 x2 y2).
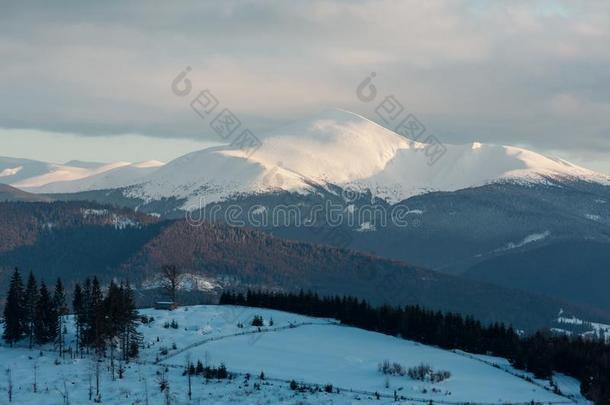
0 0 610 173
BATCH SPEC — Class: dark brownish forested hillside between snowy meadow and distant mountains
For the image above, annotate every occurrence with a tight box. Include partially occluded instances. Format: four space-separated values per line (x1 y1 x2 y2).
0 202 610 330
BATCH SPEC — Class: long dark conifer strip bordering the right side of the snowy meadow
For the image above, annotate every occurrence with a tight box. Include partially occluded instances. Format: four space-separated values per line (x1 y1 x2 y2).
220 291 610 403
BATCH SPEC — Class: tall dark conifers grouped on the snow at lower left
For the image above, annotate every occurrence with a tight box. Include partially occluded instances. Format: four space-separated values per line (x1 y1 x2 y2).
2 269 142 360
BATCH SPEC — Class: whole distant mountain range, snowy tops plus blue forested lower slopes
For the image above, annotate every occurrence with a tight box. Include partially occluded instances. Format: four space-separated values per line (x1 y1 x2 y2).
0 110 610 320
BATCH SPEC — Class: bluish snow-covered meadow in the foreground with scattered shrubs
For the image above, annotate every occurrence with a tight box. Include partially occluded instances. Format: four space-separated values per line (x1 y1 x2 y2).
0 306 584 404
